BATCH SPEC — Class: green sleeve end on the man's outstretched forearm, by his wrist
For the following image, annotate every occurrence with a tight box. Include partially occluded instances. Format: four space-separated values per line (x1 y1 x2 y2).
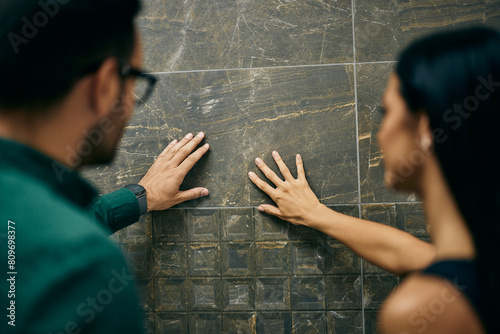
90 188 140 233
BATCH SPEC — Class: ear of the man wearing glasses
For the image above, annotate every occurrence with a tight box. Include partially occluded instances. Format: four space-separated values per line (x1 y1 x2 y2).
90 58 120 119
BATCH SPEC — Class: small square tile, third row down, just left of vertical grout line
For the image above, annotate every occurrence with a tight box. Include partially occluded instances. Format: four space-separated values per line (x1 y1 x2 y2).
325 275 361 310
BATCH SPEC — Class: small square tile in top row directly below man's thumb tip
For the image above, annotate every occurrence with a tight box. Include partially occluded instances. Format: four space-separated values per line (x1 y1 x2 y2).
186 209 220 242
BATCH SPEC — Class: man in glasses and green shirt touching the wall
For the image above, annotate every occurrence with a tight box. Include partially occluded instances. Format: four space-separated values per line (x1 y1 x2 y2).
0 0 209 334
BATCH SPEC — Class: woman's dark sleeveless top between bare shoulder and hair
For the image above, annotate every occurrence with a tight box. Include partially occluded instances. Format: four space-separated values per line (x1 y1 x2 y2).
420 259 489 333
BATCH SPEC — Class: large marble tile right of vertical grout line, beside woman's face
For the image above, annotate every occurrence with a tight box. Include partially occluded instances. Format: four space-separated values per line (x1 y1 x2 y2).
356 63 415 203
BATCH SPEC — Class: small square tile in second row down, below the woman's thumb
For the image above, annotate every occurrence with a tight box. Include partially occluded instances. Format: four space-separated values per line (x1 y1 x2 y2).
255 242 290 275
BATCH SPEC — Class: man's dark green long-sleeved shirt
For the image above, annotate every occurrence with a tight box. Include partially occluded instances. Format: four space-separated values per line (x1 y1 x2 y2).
0 139 143 334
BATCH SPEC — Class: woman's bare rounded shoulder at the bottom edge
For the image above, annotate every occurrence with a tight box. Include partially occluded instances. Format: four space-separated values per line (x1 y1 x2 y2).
379 274 484 334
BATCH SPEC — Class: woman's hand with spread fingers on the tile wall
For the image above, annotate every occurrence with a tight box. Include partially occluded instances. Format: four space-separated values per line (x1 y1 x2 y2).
248 151 322 226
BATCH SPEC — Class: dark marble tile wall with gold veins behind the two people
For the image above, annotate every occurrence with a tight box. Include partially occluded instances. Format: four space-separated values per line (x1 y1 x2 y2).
85 0 500 334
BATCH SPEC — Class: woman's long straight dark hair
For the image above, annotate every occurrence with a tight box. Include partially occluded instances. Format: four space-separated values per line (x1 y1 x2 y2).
396 27 500 333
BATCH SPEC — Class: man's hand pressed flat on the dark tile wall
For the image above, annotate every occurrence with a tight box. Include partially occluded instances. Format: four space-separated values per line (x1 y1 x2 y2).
139 132 209 211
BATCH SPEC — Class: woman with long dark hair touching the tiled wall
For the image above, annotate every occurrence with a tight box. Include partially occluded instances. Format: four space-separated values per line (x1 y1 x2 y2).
249 27 500 334
